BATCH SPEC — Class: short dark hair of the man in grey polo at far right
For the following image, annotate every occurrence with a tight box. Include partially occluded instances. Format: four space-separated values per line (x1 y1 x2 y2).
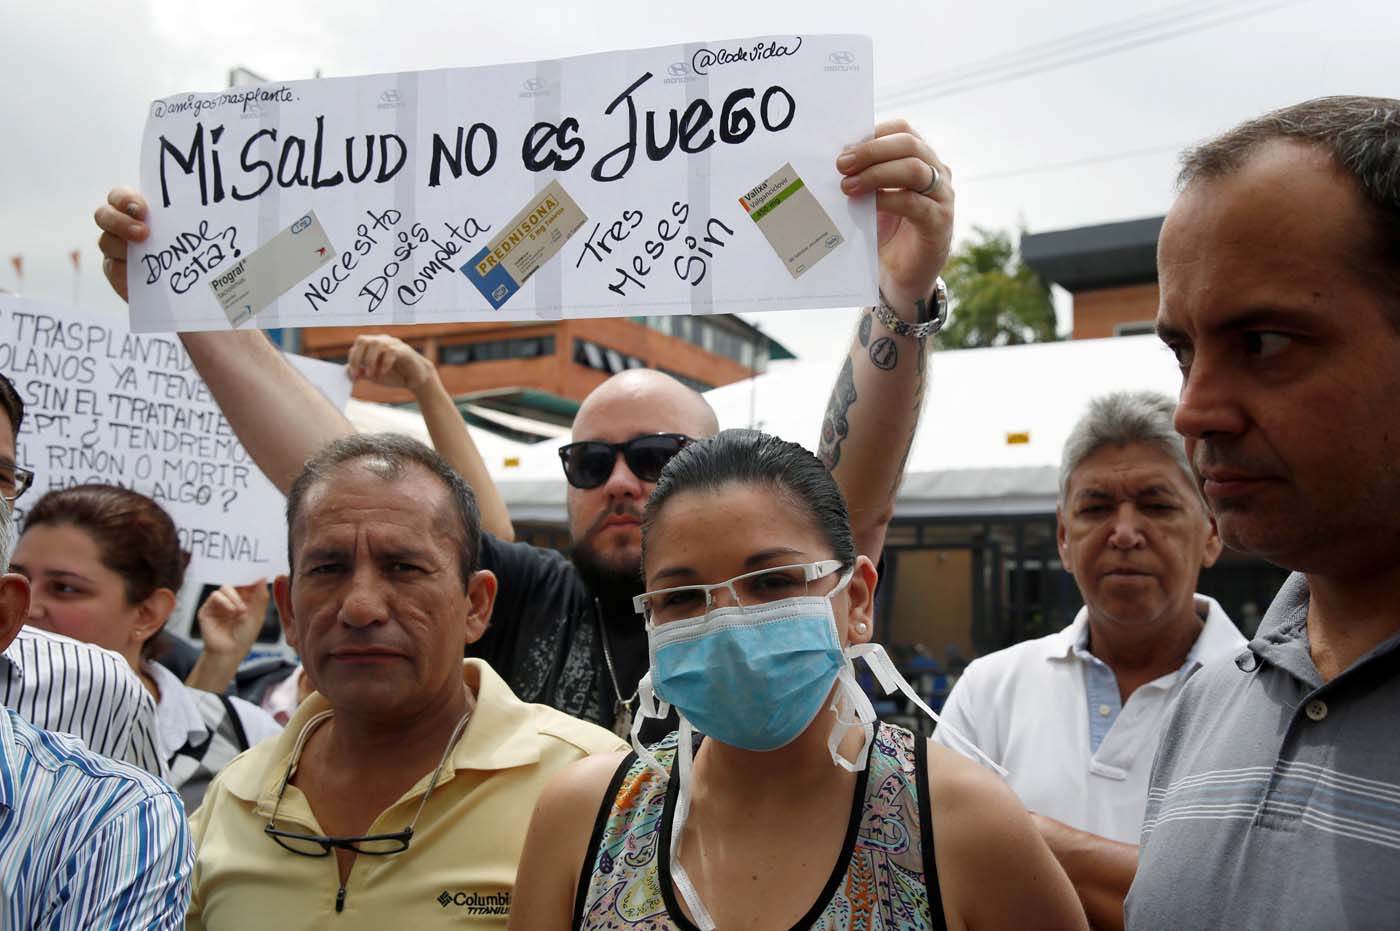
1177 97 1400 319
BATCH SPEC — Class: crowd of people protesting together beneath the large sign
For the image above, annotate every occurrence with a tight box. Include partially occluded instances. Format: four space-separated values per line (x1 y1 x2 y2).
0 98 1400 931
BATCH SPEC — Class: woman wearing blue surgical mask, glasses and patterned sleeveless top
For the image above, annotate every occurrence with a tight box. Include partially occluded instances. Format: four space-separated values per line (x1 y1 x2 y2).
511 430 1086 931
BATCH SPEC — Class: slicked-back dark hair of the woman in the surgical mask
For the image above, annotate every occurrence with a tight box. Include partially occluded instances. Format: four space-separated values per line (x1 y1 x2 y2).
641 430 855 566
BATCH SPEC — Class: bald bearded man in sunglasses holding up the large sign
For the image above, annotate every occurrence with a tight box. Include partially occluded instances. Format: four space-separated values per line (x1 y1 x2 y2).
95 120 953 732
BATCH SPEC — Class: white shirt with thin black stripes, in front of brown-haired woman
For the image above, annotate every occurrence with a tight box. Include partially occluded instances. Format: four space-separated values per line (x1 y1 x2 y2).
0 627 167 778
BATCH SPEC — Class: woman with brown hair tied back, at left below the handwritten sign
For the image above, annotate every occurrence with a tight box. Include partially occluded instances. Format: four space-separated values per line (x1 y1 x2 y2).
11 484 281 811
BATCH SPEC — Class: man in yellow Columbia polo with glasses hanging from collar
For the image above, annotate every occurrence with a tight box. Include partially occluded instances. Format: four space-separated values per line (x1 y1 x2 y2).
188 434 624 931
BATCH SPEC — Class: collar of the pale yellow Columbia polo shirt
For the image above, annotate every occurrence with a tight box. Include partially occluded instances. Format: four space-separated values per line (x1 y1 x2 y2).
224 659 540 812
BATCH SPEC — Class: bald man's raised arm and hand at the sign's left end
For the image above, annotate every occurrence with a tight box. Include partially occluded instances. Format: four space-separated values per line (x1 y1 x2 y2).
94 188 354 493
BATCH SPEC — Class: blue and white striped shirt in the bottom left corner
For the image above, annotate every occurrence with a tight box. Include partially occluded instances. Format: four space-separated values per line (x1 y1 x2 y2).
0 708 195 931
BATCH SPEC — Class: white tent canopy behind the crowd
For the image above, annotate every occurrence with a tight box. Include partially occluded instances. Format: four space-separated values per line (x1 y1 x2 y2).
487 336 1180 521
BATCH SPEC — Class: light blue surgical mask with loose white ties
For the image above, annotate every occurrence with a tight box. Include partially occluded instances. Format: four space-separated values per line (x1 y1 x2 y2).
631 568 1007 931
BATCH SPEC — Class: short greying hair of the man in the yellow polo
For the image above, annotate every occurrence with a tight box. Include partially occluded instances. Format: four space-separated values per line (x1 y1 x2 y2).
287 433 482 587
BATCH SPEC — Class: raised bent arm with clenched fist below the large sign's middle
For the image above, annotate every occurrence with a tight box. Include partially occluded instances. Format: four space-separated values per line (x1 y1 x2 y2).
346 335 515 540
